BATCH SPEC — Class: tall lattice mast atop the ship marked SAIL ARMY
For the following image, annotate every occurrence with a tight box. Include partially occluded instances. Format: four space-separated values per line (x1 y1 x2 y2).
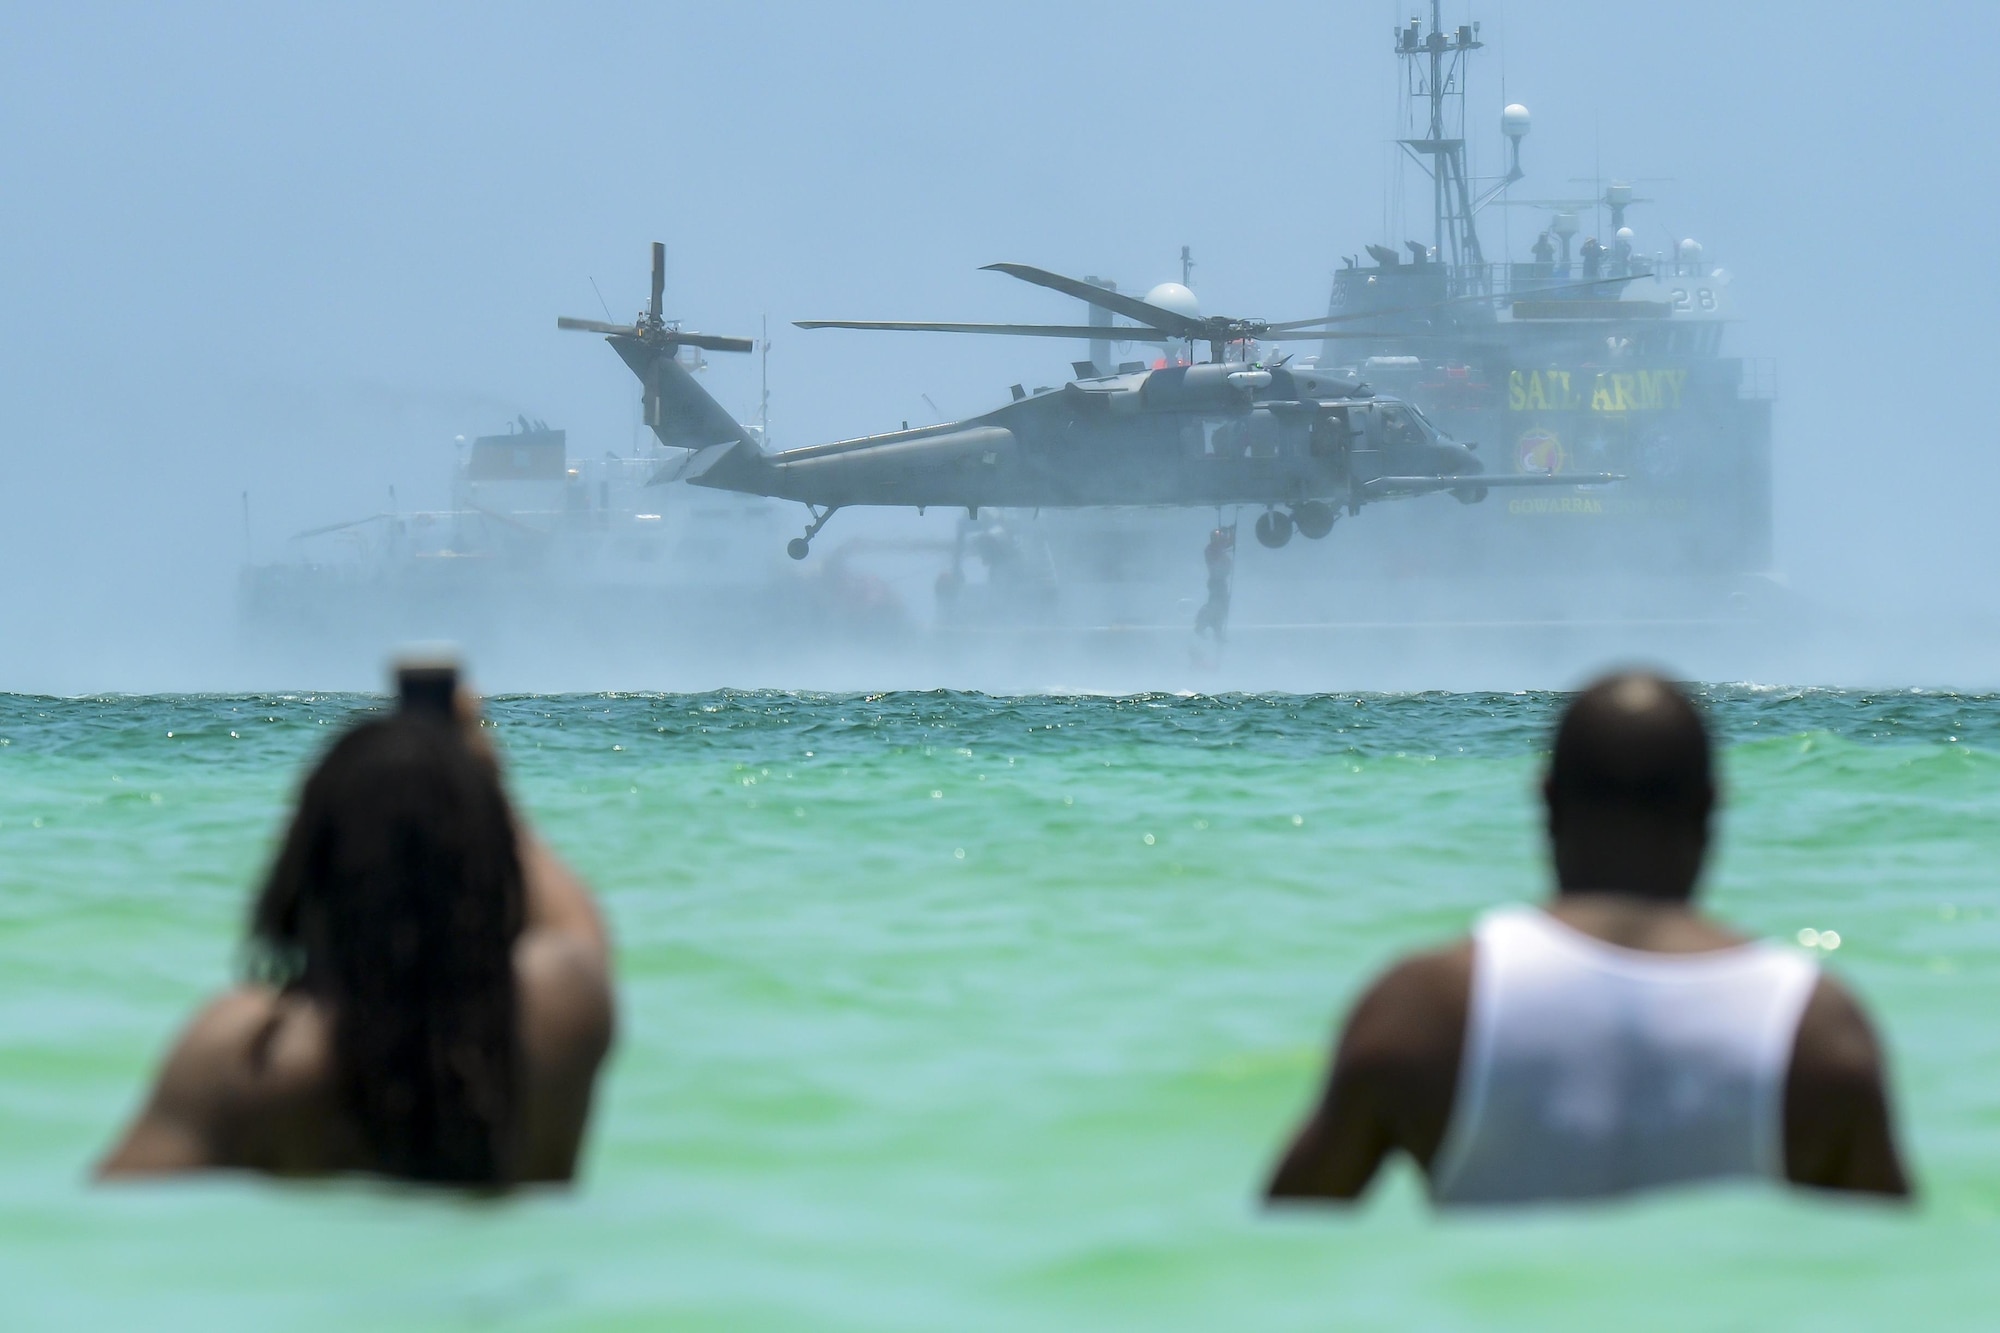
1396 0 1486 268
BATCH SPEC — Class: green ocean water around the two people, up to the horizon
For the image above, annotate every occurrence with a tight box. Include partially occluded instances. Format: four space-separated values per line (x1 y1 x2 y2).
0 687 2000 1329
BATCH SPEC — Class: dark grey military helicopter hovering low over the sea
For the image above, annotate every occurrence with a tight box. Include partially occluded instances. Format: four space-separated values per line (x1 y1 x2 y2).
556 242 1620 560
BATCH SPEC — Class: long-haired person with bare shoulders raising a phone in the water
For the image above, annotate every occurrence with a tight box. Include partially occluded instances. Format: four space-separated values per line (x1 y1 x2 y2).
100 709 612 1187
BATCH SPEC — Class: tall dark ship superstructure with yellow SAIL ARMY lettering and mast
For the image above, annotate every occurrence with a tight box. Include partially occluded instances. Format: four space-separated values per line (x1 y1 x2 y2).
1320 0 1774 576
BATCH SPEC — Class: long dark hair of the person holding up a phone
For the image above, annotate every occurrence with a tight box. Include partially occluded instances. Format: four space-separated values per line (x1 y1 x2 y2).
250 713 524 1185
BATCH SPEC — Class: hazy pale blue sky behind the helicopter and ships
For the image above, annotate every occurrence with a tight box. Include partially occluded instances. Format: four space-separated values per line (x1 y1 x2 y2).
0 0 2000 693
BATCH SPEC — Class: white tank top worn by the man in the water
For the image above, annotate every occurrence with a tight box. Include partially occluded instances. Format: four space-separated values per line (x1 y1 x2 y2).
1430 907 1818 1203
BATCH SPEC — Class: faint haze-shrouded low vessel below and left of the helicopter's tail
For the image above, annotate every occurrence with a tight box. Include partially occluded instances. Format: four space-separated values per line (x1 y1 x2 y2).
238 418 920 689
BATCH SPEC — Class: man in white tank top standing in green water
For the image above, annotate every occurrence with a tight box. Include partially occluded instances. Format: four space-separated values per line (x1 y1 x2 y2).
1268 675 1910 1205
